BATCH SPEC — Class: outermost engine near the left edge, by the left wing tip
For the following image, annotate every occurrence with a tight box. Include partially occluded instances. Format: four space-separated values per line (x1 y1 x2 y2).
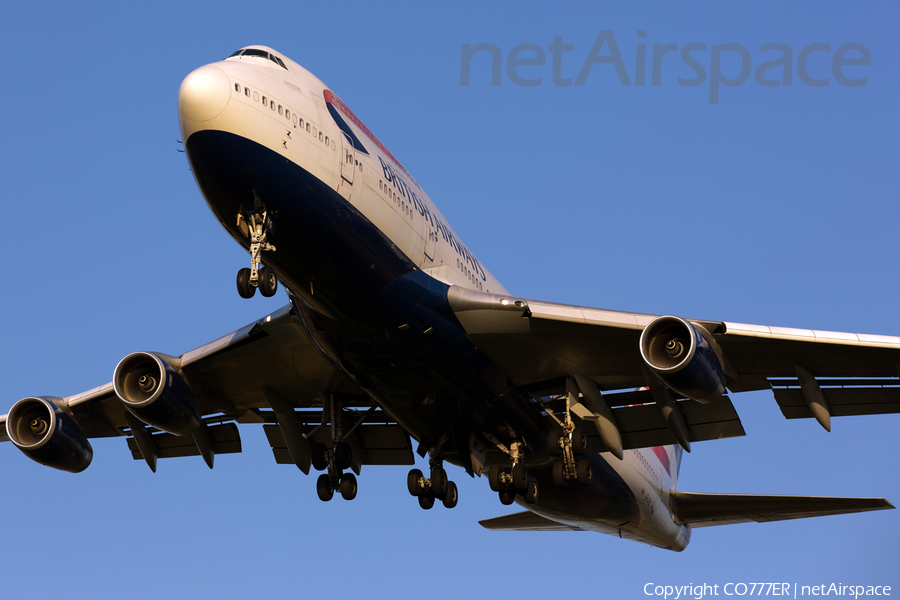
6 397 94 473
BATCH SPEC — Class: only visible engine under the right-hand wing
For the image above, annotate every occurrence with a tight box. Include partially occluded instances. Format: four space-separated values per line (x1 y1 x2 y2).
641 317 725 402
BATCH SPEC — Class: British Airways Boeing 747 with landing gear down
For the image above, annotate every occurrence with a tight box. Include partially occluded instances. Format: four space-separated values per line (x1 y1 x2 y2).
0 46 900 551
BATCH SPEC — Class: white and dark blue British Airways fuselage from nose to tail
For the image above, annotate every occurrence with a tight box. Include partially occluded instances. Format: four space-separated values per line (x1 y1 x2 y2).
179 46 690 550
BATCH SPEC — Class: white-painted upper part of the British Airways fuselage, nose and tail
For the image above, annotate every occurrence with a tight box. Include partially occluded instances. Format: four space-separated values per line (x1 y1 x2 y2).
179 46 690 551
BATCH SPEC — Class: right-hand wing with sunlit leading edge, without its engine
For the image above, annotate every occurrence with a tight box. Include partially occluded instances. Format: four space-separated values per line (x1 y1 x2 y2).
449 286 900 425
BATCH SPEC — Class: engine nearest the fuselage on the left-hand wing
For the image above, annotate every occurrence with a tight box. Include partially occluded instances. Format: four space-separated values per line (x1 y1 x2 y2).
113 352 201 435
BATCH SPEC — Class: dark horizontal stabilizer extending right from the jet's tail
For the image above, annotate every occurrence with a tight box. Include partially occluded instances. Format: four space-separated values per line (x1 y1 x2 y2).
669 492 894 527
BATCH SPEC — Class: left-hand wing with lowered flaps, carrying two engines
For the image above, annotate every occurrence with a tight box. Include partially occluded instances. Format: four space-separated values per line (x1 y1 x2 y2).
0 305 413 471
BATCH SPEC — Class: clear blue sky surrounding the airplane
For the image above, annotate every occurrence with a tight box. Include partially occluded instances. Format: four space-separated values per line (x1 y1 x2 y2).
0 1 900 598
